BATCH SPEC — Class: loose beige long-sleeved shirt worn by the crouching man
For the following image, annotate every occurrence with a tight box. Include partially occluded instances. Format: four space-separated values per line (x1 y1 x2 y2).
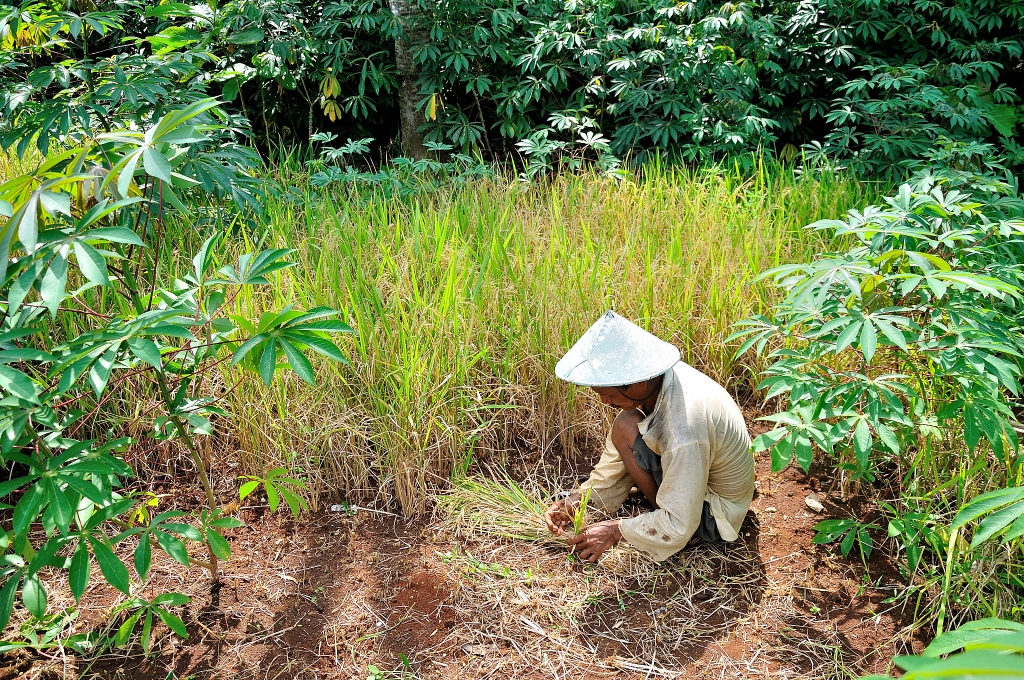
582 362 754 560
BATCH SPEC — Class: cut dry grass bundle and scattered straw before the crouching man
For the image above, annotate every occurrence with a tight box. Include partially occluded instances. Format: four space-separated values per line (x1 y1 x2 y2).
439 479 766 678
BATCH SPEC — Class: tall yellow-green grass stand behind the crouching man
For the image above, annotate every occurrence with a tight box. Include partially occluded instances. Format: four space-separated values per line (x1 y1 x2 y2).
186 161 865 512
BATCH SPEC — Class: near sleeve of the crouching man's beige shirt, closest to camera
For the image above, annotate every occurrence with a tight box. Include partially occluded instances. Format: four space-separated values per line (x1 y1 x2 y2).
618 441 711 560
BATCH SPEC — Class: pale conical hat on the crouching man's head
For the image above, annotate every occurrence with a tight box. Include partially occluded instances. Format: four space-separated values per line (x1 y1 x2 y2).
555 309 679 387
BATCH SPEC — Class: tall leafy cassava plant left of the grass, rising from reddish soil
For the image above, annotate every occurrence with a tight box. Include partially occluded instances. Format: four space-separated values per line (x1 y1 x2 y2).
0 99 350 646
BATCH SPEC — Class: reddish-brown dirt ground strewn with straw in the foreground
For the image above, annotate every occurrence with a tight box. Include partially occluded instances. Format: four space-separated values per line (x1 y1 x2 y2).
0 417 922 680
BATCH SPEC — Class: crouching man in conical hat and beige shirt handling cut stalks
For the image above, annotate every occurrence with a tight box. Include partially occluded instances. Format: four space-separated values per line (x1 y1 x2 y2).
545 311 754 562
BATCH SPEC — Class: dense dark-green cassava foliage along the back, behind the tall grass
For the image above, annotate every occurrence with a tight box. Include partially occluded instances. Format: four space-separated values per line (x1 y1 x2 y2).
0 0 1024 178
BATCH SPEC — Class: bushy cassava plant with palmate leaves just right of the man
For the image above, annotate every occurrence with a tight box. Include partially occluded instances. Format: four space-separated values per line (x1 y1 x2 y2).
732 157 1024 489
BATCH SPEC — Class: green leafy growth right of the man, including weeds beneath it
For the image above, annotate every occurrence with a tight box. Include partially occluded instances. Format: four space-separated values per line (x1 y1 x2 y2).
735 143 1024 628
